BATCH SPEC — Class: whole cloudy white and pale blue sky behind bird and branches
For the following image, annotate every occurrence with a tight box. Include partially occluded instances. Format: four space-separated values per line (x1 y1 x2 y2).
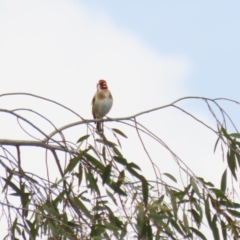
0 0 240 238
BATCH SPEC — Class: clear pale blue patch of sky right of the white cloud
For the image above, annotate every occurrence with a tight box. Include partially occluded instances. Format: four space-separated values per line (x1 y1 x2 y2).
80 0 240 100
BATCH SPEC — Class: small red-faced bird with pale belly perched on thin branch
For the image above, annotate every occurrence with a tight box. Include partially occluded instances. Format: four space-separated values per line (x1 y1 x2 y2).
92 79 113 132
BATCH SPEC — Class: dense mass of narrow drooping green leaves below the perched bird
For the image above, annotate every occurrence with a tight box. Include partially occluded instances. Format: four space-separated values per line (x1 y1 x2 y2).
1 96 240 240
